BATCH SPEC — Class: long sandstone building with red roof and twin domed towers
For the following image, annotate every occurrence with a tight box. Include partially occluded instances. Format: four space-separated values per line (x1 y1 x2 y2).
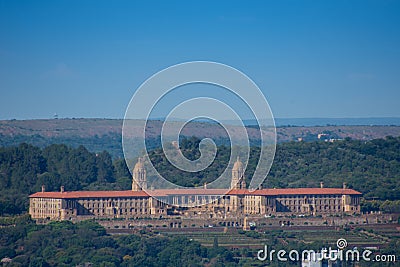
29 159 361 220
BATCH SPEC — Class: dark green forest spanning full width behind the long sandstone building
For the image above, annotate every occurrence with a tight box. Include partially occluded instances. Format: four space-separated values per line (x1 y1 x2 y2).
0 137 400 215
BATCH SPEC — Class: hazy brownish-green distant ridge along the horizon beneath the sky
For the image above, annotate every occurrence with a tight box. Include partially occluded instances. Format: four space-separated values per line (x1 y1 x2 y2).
0 119 400 158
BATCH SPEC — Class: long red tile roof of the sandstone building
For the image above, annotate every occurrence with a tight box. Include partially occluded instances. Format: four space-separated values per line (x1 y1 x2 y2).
29 188 362 199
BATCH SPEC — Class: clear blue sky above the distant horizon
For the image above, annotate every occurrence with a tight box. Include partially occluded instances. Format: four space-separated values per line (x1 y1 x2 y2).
0 0 400 119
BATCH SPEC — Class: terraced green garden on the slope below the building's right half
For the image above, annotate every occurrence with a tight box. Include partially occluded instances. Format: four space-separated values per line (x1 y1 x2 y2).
160 224 400 249
